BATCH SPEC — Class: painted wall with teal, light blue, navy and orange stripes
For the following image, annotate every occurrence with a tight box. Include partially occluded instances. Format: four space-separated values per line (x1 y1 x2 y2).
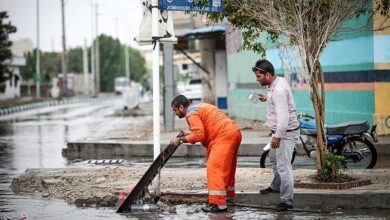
226 13 390 134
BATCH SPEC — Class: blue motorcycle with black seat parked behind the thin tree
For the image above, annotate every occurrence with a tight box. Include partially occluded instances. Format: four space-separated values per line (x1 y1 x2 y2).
260 113 378 169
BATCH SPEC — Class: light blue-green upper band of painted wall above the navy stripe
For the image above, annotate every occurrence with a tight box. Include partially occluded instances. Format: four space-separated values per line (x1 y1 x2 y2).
227 36 375 75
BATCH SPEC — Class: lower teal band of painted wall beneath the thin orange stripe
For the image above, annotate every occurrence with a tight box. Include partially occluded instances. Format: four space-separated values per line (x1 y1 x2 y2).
228 89 375 125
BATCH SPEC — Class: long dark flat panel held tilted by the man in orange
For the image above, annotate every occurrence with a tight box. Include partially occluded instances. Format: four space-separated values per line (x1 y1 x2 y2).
116 131 184 213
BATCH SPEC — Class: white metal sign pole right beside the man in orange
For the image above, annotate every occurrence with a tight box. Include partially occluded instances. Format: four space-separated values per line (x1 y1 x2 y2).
152 0 160 195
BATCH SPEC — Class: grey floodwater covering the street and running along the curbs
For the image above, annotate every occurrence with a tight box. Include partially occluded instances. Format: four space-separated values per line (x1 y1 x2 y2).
0 99 390 219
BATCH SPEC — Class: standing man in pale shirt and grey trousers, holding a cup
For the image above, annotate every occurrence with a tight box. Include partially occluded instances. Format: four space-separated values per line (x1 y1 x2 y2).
252 59 299 211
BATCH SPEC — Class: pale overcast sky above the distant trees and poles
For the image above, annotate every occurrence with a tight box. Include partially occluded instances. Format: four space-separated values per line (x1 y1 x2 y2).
0 0 142 51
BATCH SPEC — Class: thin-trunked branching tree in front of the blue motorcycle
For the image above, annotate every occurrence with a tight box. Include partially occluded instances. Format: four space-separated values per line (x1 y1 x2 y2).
206 0 390 170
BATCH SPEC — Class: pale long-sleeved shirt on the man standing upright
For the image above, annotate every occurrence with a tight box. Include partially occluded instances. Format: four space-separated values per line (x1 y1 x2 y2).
266 77 299 138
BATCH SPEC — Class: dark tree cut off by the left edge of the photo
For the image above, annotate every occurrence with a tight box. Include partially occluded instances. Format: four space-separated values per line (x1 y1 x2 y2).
0 11 16 83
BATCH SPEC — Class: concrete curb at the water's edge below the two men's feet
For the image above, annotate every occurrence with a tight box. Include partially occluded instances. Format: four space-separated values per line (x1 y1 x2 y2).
162 189 390 210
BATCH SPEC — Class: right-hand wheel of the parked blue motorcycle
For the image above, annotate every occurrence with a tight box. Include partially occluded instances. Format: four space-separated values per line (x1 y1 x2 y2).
338 137 377 169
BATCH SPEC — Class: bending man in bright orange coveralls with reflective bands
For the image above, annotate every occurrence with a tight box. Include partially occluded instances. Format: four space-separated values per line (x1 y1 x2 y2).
171 95 242 213
